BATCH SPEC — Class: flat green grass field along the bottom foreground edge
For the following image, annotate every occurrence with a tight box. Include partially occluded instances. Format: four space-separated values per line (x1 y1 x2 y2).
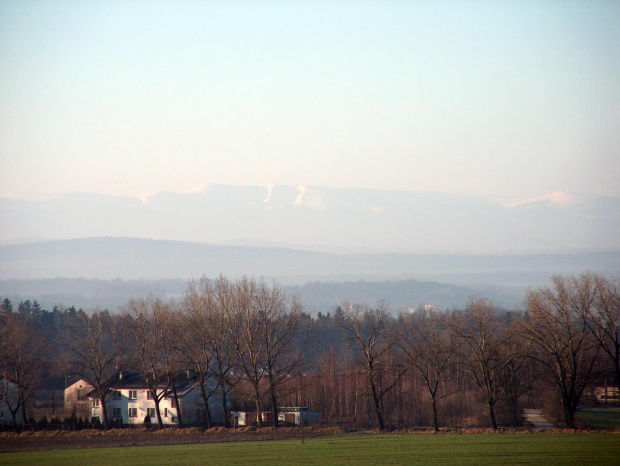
0 433 620 466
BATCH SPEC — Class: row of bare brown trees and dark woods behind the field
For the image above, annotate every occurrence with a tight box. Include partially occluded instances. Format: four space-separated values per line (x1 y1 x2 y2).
0 274 620 430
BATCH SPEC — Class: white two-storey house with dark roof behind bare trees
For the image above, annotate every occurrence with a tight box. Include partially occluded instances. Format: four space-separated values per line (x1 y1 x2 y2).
87 375 222 425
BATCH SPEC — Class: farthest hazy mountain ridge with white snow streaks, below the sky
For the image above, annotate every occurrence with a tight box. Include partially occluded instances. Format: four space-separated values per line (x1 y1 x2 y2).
0 185 620 254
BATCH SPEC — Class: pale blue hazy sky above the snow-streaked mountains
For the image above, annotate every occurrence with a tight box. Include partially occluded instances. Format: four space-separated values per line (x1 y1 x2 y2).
0 0 620 197
